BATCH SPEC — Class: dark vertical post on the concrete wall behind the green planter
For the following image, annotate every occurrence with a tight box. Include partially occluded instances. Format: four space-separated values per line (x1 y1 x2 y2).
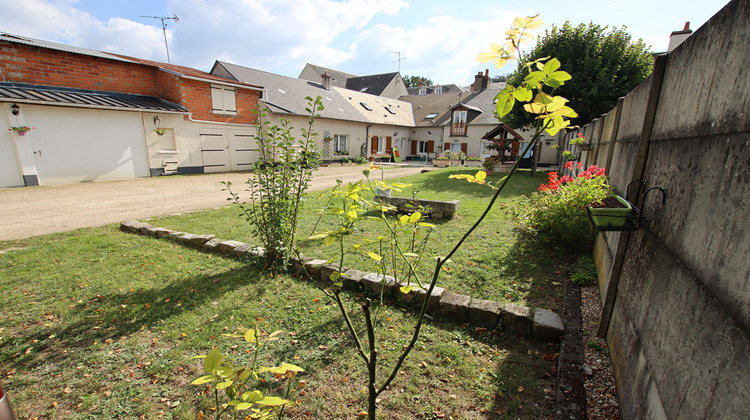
597 54 667 338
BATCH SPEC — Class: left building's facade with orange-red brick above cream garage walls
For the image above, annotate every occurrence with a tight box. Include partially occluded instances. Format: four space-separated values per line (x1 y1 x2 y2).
0 34 262 187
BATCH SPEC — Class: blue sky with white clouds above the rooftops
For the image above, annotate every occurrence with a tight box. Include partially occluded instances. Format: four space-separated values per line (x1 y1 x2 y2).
0 0 727 85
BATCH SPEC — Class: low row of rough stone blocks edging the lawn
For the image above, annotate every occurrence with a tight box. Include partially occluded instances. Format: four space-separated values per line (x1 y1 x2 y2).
120 220 565 340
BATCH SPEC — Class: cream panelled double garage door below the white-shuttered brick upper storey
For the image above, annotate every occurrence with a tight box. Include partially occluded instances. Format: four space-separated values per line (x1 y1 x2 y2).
200 129 258 173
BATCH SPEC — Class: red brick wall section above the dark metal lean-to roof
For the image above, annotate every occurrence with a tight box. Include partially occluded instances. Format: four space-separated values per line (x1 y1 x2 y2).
0 42 160 96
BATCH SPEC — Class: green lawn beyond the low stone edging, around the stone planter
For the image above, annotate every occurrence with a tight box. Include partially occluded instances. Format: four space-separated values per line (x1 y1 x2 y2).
150 168 564 310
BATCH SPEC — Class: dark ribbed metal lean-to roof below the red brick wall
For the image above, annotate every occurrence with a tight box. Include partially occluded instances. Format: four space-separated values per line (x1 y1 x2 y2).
0 82 188 112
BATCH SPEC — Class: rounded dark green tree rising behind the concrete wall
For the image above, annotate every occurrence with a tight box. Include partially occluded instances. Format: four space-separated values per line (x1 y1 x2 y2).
503 22 653 128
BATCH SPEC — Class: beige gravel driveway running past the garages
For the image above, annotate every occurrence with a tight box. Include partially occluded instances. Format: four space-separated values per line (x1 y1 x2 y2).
0 165 432 241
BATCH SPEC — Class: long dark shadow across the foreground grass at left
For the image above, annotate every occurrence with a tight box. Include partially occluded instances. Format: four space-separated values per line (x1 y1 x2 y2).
0 265 266 367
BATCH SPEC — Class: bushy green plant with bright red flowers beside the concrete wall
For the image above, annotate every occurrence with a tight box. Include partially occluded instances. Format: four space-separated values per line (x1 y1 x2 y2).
517 161 611 246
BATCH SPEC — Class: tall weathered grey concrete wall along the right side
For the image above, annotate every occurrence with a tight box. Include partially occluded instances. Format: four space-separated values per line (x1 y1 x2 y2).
595 0 750 419
